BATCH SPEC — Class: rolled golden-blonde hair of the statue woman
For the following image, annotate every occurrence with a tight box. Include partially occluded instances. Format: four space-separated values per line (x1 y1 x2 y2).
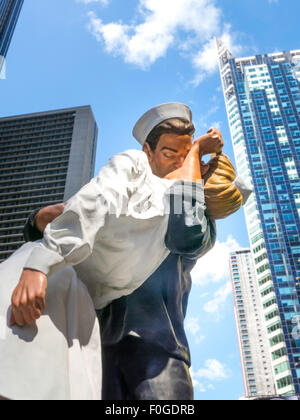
203 153 243 219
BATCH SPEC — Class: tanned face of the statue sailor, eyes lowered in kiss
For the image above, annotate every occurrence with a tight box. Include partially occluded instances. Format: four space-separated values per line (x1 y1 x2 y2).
144 133 193 178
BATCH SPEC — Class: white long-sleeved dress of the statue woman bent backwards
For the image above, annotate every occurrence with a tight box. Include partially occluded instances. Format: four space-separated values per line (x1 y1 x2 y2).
0 150 180 400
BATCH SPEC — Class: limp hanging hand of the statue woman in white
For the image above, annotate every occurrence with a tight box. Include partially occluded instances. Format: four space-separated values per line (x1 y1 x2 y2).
9 269 47 327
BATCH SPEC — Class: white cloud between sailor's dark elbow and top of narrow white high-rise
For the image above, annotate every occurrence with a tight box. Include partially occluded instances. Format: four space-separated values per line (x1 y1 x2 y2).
192 235 241 286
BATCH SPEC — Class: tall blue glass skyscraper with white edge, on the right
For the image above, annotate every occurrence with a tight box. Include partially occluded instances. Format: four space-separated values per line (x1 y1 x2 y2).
217 40 300 395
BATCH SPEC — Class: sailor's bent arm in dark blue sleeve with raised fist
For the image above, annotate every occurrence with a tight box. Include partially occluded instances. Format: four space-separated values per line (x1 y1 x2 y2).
165 128 220 259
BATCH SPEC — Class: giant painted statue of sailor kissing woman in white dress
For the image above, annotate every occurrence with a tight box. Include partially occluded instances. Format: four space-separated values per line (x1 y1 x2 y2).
0 103 250 400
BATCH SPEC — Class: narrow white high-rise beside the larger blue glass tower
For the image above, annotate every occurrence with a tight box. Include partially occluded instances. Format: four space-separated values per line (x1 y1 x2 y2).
230 249 276 399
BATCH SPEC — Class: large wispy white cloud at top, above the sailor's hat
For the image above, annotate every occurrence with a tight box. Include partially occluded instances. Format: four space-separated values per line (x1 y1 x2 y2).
83 0 238 81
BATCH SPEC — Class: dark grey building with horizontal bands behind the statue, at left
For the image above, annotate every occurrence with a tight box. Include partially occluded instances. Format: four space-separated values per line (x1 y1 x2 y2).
0 106 98 262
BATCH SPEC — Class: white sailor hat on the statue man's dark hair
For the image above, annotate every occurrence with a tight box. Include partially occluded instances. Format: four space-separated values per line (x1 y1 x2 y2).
133 102 193 145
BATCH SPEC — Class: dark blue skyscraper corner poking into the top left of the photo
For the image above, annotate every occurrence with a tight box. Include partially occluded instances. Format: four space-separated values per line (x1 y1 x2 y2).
0 0 24 66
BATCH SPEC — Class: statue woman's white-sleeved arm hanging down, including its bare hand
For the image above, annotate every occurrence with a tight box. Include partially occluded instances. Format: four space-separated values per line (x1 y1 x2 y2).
10 153 139 326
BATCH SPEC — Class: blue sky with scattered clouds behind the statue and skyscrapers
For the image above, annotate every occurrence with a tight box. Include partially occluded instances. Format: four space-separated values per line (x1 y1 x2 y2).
0 0 300 400
